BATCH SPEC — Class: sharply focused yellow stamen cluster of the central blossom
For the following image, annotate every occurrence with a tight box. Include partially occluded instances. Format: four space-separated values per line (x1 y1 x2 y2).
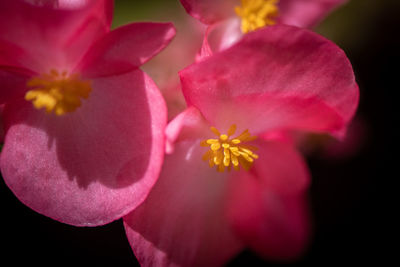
200 124 258 172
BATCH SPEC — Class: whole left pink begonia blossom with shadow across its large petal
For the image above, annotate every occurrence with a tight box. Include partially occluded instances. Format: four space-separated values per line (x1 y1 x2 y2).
0 0 175 226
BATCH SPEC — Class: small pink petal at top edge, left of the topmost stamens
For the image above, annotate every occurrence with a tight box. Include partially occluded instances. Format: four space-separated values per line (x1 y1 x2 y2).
180 0 239 24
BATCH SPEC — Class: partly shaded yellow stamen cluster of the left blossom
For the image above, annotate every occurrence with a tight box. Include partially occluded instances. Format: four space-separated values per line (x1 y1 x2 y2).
25 69 92 115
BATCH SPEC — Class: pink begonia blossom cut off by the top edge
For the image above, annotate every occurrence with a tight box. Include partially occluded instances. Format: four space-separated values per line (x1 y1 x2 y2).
180 0 347 54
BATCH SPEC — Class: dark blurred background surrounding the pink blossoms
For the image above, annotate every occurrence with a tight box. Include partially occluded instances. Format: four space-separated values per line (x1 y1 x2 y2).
0 0 400 266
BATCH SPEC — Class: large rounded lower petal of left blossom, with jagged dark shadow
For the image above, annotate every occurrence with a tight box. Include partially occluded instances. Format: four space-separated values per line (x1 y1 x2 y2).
0 70 167 226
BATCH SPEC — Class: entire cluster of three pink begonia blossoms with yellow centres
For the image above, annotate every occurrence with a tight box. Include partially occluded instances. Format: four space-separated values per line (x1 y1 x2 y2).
0 0 359 266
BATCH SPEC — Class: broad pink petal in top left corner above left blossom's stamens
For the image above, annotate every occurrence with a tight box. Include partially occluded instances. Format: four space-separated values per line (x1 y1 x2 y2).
0 0 112 72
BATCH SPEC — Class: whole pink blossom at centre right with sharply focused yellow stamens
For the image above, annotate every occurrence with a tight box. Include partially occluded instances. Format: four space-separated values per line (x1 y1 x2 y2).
124 25 359 266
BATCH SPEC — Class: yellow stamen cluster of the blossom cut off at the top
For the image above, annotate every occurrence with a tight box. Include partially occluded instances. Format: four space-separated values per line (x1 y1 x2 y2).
235 0 279 33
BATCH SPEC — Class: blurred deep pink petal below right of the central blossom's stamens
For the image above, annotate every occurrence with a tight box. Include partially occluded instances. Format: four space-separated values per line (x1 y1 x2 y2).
228 142 310 260
